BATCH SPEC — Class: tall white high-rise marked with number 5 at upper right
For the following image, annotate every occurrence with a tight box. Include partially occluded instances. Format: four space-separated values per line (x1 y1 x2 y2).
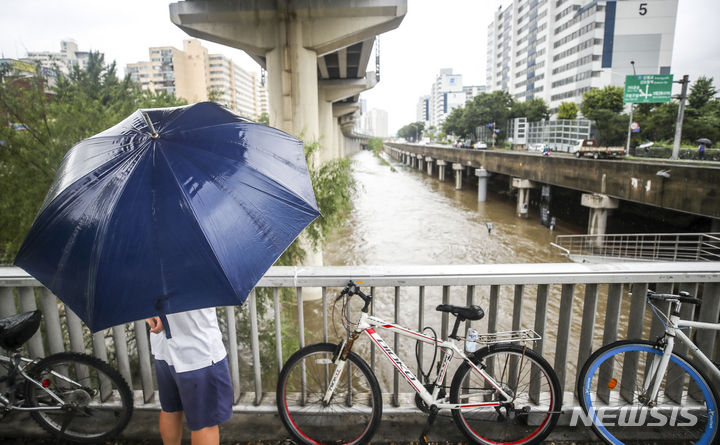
486 0 678 108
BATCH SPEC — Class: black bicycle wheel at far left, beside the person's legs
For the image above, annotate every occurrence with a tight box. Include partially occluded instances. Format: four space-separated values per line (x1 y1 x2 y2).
25 352 133 443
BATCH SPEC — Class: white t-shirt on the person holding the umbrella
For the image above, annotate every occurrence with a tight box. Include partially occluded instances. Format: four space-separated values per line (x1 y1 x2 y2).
150 308 227 372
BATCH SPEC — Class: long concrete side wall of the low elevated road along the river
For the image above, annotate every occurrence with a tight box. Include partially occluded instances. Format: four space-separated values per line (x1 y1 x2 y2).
385 143 720 218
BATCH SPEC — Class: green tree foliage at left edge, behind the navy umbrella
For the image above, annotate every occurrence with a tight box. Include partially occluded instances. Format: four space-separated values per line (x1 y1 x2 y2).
0 53 184 262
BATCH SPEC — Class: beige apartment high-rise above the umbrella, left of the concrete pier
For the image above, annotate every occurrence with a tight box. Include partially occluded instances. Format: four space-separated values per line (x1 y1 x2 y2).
126 39 268 119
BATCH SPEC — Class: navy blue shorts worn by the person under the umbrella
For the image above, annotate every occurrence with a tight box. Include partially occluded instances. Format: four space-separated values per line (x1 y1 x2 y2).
155 357 233 431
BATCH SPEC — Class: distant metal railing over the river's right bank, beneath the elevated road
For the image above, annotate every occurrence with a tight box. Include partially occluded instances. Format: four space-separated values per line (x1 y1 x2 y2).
552 233 720 263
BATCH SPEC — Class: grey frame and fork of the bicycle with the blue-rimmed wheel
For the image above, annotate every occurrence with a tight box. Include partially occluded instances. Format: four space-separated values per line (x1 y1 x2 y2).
643 301 720 400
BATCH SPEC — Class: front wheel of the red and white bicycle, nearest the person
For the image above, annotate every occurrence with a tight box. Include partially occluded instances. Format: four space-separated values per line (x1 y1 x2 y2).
277 343 382 444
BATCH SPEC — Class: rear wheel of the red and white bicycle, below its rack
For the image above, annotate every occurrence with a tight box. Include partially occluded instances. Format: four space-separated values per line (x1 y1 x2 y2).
450 344 562 444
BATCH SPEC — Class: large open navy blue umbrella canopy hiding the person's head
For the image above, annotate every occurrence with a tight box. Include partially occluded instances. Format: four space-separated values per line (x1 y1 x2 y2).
15 102 320 332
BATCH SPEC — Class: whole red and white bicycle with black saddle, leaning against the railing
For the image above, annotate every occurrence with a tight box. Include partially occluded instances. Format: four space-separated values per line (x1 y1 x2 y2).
277 282 562 444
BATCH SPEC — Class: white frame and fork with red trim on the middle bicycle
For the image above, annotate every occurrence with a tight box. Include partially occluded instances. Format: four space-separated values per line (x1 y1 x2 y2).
323 312 512 409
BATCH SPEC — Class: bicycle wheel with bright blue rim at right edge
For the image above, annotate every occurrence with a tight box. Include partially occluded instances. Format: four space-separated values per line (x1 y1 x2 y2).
577 340 718 444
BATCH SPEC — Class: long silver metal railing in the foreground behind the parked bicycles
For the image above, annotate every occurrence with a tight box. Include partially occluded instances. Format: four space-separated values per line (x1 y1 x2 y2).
0 262 720 418
